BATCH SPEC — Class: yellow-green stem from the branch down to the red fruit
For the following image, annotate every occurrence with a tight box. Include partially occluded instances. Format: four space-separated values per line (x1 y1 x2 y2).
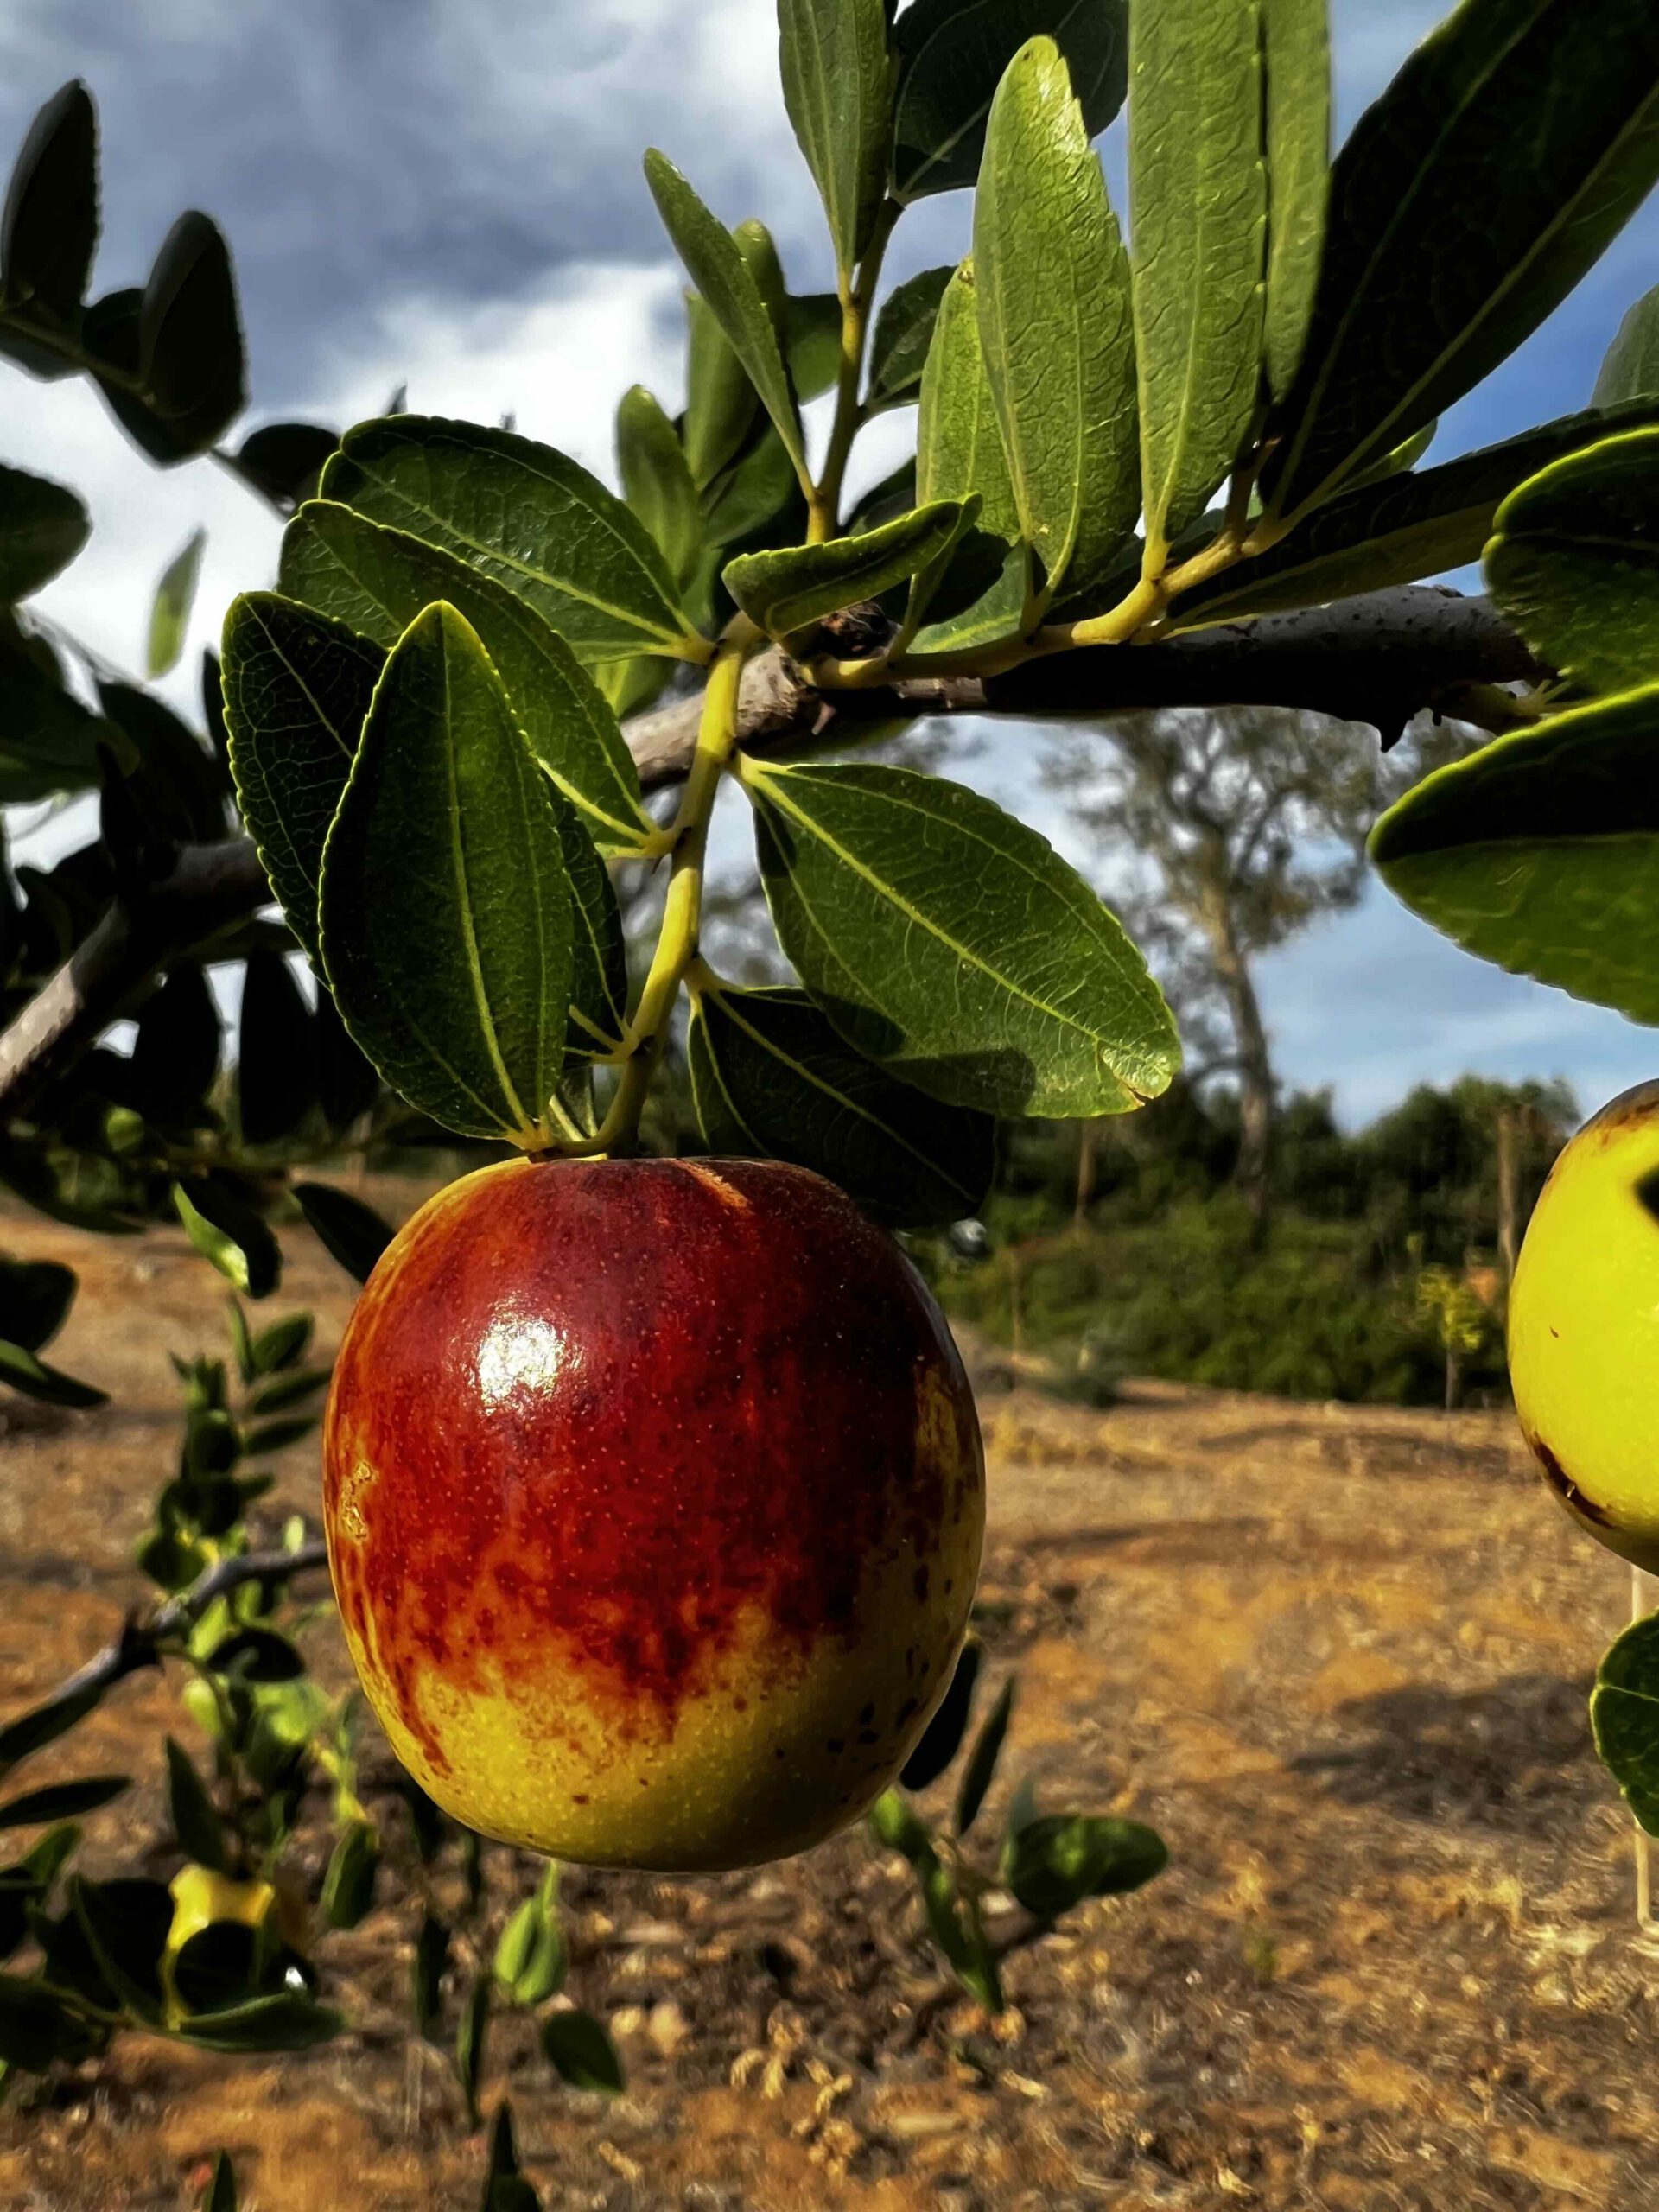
557 615 763 1159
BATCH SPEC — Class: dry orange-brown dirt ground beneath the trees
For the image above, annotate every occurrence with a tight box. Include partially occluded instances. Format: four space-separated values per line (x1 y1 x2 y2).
0 1221 1659 2212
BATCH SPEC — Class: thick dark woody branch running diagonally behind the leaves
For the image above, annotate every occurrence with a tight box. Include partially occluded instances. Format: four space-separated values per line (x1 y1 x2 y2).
0 584 1544 1122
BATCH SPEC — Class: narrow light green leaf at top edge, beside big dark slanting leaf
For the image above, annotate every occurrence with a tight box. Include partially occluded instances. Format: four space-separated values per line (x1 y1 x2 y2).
1261 0 1332 398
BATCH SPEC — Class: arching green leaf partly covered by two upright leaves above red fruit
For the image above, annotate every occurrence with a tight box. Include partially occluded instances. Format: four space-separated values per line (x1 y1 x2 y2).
281 500 666 854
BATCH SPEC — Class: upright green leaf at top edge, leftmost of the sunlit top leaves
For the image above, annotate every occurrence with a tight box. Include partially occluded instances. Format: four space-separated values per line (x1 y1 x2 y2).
779 0 893 274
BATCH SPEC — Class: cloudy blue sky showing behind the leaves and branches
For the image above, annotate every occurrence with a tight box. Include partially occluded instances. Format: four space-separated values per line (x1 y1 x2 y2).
0 0 1659 1122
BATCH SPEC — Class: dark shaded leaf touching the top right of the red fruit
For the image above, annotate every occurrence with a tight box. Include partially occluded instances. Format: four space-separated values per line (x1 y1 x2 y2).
686 976 995 1230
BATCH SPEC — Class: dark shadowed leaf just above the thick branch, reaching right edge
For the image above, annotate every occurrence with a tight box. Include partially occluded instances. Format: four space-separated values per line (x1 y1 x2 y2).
1174 403 1655 631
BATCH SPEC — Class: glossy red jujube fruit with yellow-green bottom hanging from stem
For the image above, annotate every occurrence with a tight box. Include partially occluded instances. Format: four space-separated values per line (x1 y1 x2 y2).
323 1159 984 1869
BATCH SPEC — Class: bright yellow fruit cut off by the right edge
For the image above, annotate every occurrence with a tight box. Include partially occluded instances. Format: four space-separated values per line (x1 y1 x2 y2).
1509 1082 1659 1573
